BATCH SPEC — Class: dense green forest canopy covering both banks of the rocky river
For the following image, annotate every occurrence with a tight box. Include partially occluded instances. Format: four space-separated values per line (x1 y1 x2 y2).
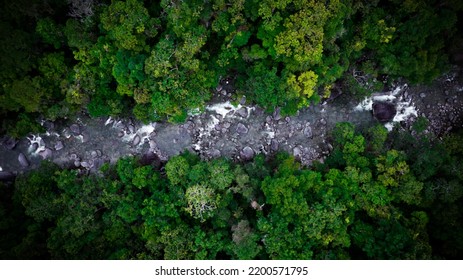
0 0 463 259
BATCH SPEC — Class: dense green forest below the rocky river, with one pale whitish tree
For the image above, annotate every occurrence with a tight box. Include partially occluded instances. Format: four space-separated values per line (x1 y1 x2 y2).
0 123 463 259
